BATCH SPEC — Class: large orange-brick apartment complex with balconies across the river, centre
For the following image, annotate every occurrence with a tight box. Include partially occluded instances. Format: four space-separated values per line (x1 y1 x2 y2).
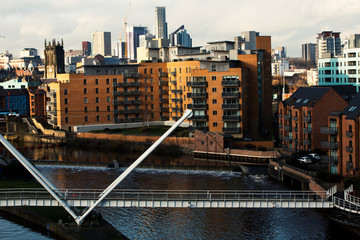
45 36 272 139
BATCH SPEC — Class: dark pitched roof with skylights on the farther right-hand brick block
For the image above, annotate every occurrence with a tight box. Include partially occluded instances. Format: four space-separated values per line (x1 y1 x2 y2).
284 87 330 108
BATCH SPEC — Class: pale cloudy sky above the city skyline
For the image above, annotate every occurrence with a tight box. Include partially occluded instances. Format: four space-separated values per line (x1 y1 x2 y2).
0 0 360 57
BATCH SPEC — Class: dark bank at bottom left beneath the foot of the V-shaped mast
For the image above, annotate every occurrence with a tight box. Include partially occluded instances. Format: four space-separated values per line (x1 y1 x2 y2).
0 207 128 240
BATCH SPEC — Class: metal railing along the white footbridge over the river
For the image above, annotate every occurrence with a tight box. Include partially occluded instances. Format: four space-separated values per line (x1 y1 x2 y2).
0 189 327 201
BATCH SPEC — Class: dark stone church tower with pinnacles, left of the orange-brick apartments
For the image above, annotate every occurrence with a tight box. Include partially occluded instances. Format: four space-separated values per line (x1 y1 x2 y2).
44 39 65 78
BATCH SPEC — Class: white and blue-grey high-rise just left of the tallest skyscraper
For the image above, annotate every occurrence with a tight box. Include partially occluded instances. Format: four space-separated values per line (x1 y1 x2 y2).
126 26 148 61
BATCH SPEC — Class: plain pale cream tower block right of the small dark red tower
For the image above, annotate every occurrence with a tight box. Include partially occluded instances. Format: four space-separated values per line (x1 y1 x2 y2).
92 32 111 56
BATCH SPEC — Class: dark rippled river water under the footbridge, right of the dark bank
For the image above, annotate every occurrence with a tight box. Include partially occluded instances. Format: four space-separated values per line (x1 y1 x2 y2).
0 144 356 239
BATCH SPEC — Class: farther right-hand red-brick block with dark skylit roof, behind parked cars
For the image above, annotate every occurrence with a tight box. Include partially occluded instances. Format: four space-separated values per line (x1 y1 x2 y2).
279 86 356 152
